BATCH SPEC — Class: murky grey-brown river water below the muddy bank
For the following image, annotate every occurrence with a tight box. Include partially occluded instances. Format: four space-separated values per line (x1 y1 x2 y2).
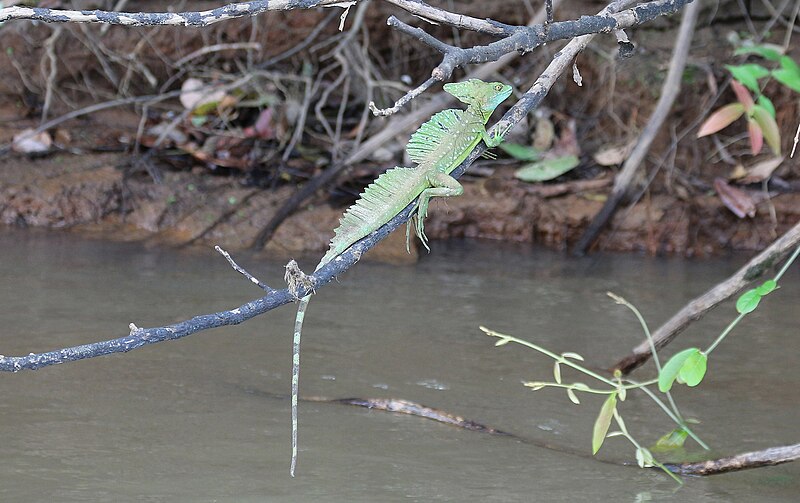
0 230 800 502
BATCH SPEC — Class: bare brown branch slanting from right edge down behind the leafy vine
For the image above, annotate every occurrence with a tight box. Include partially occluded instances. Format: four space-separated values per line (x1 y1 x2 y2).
612 222 800 374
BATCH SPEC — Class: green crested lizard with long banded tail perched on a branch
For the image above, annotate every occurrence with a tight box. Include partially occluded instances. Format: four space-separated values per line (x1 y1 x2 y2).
290 79 511 476
